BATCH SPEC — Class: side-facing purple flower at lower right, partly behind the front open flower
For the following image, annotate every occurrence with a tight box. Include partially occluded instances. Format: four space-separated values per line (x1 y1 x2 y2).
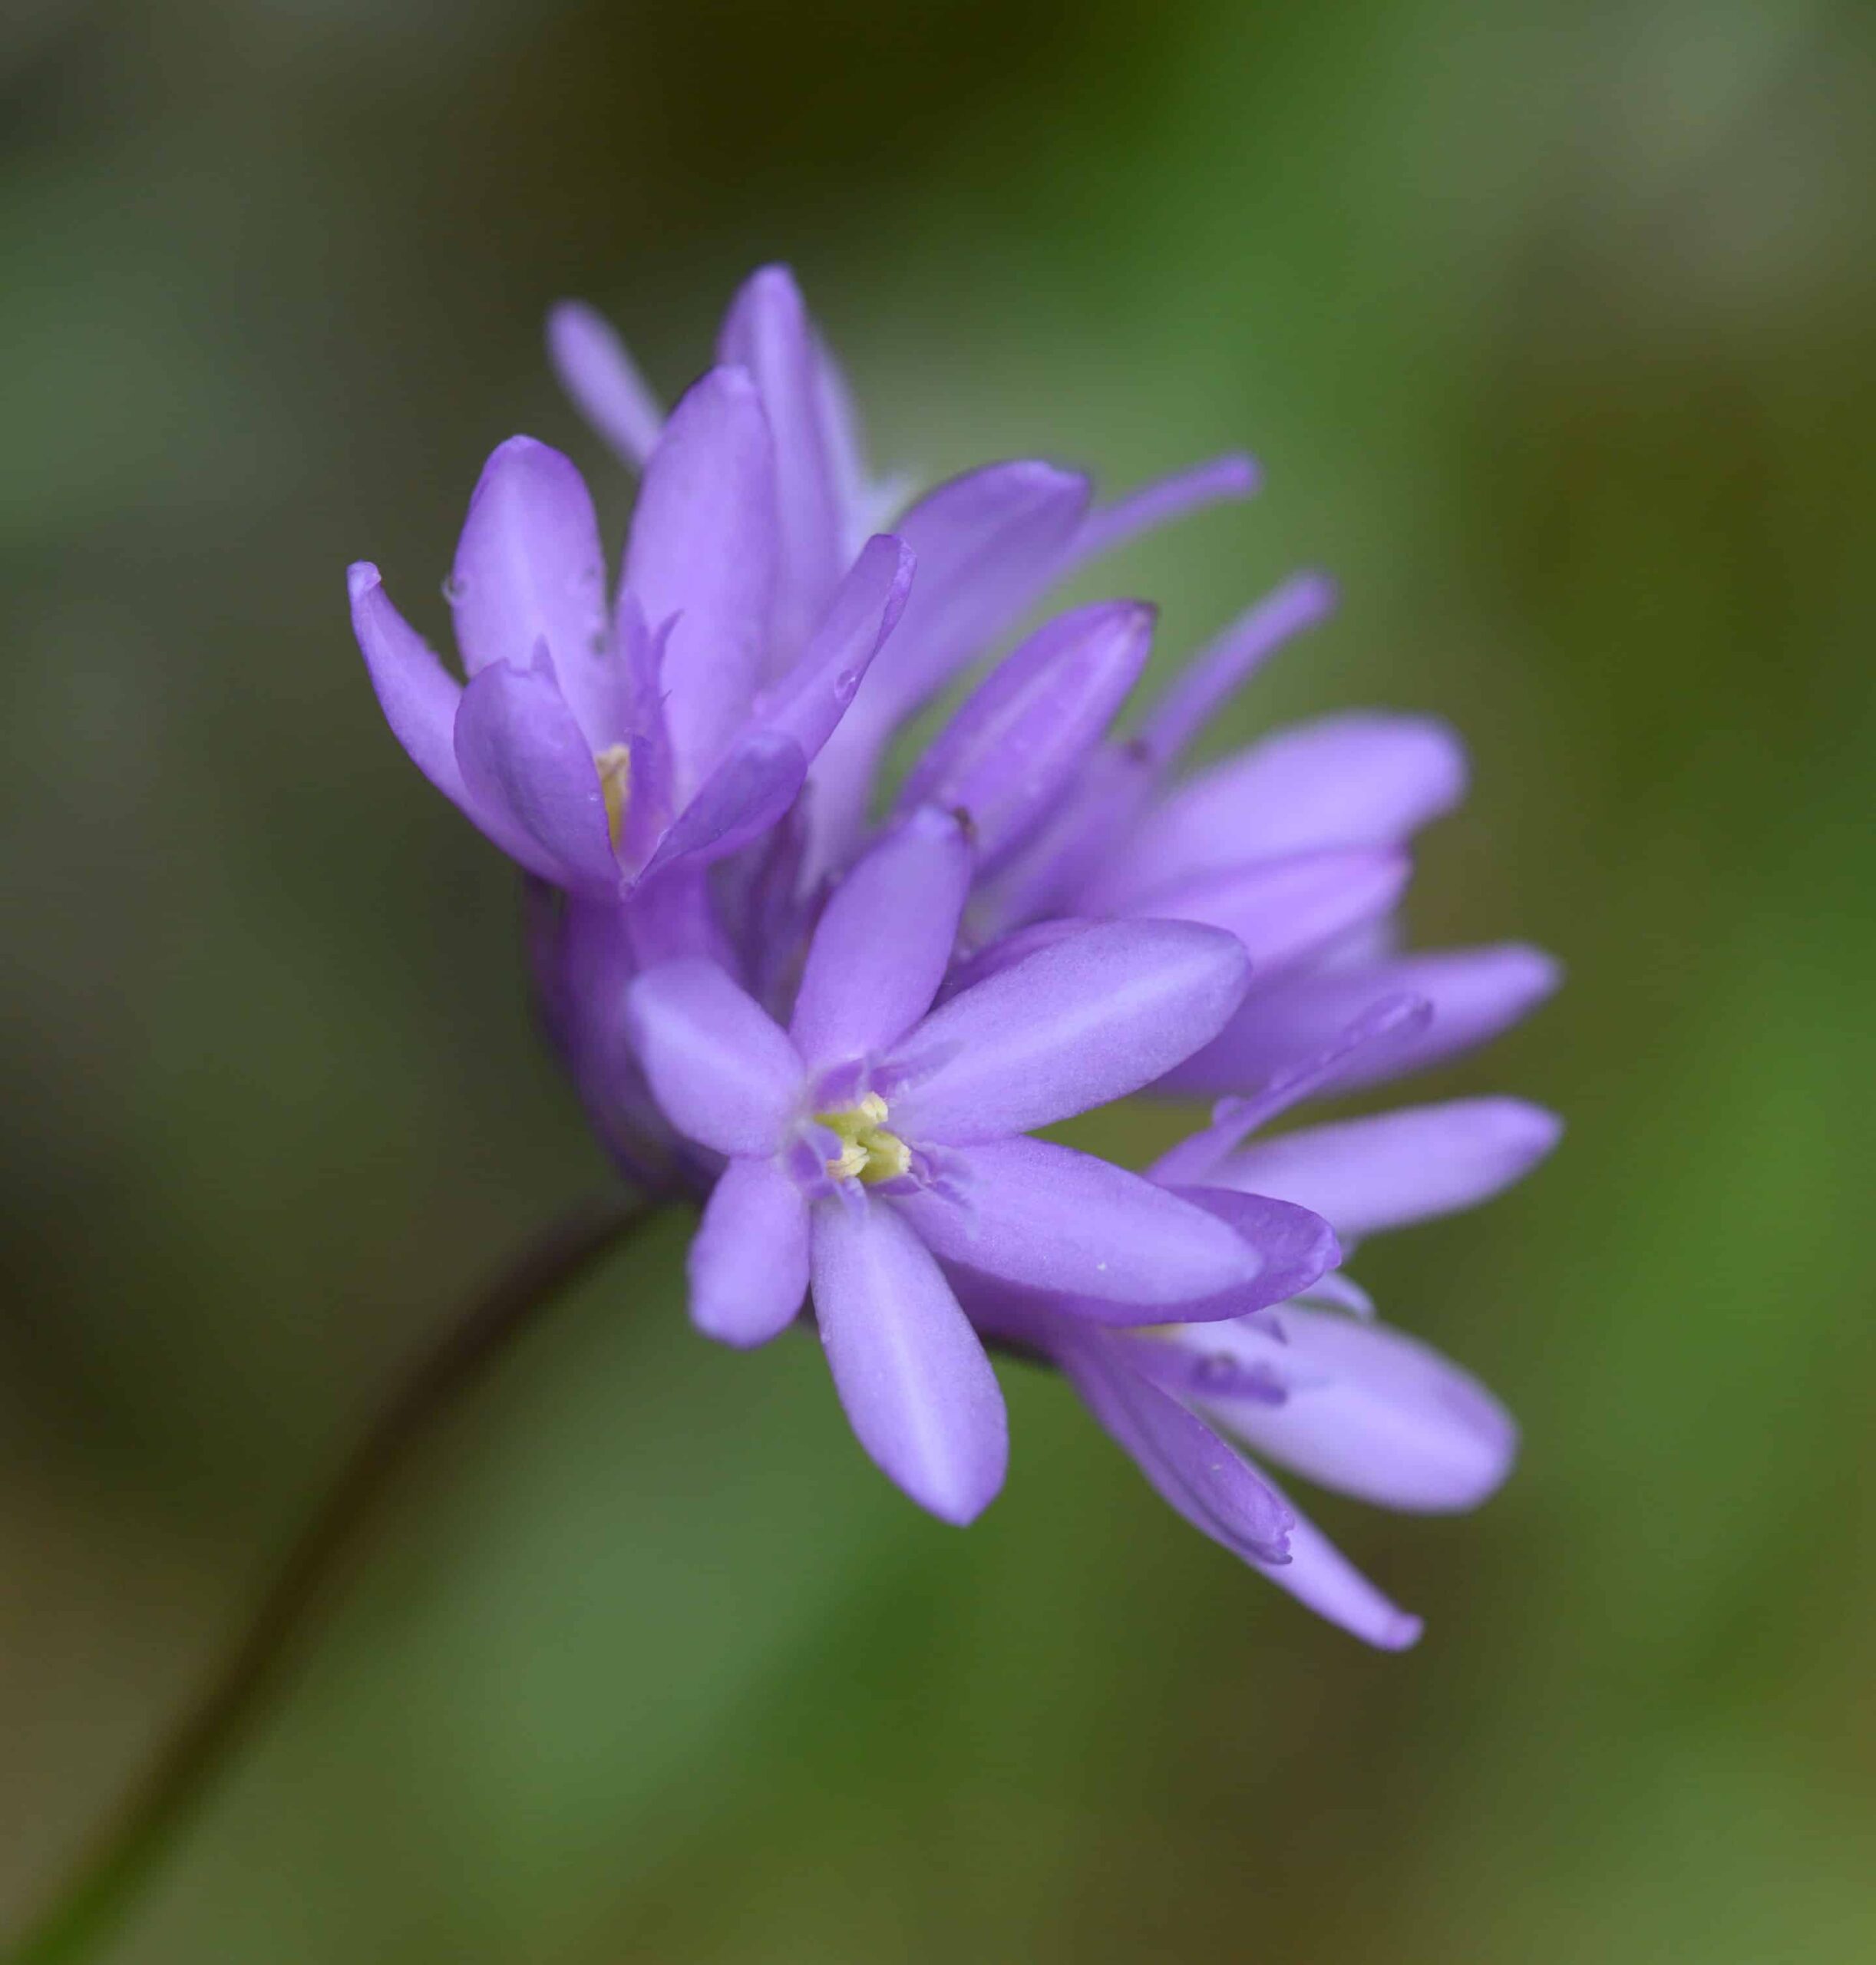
965 998 1560 1649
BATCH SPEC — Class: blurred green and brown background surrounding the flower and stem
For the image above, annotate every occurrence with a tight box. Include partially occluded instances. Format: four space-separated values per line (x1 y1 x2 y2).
0 0 1876 1965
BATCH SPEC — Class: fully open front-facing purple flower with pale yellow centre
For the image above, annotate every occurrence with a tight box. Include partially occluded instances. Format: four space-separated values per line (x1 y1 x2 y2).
629 807 1334 1523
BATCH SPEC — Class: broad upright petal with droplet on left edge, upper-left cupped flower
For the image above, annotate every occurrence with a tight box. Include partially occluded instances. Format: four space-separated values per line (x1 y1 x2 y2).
450 436 625 751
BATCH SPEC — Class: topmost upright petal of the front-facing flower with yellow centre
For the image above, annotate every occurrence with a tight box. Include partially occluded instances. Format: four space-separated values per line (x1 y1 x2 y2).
790 810 970 1069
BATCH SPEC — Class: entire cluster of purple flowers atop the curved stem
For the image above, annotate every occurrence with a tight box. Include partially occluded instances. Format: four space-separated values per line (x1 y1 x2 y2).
350 267 1556 1645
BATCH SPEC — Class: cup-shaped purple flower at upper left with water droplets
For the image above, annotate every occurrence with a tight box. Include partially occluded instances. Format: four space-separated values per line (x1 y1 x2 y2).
350 414 913 902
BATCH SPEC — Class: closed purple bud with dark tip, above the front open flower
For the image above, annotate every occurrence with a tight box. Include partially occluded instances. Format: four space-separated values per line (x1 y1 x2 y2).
900 601 1153 873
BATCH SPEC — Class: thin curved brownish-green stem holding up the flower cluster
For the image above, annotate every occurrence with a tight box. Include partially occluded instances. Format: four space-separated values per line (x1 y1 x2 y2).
6 1199 660 1965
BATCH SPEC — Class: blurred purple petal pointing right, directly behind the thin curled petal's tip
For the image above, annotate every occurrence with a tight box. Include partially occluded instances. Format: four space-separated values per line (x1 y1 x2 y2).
1161 943 1560 1092
